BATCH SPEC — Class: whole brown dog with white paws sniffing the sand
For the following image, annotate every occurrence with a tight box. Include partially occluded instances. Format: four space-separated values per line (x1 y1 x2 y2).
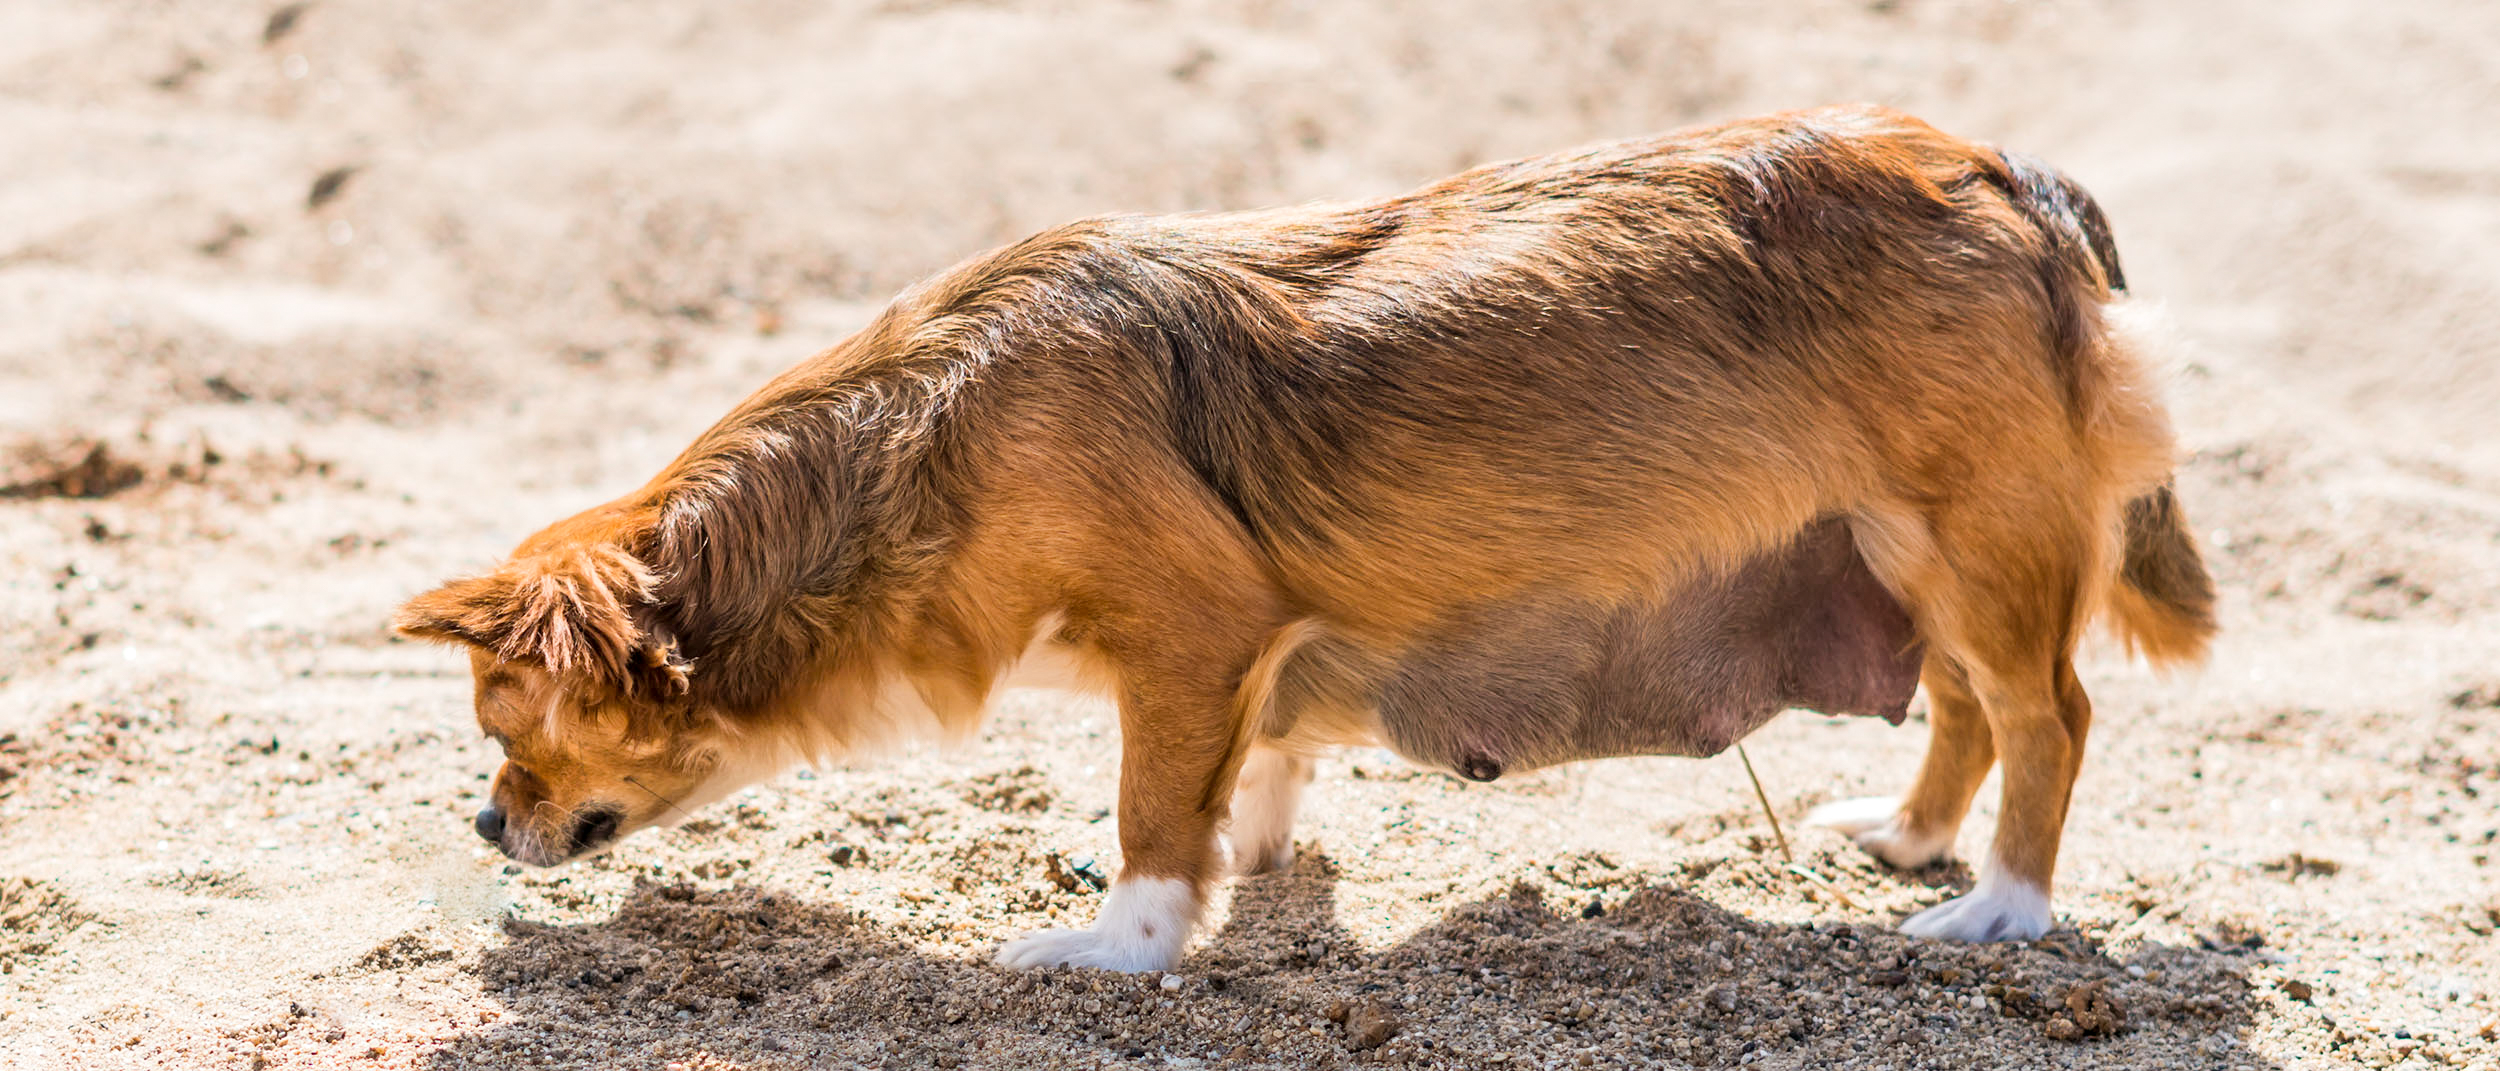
395 108 2215 971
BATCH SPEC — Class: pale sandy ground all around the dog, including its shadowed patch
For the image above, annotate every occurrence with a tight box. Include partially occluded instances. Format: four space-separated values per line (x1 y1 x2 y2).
0 0 2500 1071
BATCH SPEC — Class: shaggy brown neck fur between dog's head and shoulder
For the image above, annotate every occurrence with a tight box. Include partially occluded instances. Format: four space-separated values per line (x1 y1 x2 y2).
638 310 1003 725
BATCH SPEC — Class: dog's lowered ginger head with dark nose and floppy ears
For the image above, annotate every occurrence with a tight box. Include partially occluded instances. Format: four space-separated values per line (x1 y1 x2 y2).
393 536 735 866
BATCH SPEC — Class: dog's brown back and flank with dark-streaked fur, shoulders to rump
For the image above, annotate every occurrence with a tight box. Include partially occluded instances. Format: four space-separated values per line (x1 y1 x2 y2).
918 110 2200 638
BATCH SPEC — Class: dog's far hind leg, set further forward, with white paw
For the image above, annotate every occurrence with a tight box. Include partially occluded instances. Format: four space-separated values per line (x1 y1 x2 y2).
1805 651 1998 866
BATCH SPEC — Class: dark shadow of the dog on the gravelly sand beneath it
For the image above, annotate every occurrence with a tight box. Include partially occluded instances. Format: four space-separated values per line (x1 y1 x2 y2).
428 853 2273 1071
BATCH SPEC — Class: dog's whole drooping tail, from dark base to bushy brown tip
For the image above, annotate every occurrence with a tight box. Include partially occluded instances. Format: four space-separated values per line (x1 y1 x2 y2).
1995 153 2215 666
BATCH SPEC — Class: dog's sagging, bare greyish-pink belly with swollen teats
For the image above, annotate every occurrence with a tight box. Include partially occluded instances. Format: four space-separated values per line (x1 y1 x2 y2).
1375 520 1920 781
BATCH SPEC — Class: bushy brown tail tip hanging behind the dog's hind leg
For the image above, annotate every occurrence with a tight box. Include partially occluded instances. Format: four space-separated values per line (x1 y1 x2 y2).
2108 483 2215 666
